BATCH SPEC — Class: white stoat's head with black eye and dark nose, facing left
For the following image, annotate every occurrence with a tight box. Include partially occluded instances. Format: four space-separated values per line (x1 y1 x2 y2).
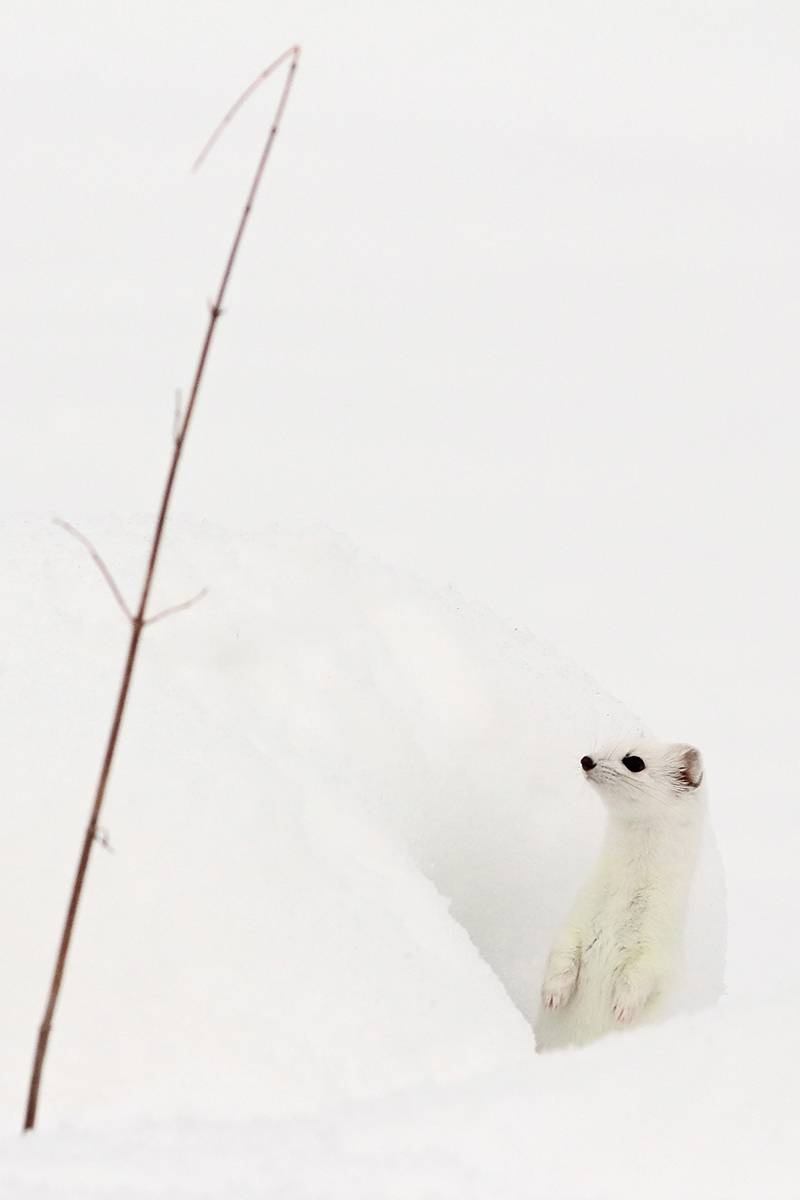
581 739 703 817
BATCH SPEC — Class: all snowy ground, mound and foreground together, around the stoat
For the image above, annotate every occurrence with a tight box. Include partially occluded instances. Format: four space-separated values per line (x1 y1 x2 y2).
0 520 800 1200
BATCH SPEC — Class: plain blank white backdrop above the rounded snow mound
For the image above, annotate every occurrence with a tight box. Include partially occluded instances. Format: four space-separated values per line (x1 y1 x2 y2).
0 0 800 806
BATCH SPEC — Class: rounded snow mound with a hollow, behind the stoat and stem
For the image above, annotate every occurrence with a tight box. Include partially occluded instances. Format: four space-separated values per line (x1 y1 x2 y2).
0 521 723 1123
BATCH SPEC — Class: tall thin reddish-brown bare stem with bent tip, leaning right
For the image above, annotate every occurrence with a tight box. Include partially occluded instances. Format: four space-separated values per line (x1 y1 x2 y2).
24 46 300 1129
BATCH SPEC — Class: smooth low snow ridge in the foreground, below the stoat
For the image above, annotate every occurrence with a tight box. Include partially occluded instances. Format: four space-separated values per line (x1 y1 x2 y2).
0 1001 800 1200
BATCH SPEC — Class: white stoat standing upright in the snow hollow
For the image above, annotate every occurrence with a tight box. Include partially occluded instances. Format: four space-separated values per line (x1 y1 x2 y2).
535 739 706 1050
